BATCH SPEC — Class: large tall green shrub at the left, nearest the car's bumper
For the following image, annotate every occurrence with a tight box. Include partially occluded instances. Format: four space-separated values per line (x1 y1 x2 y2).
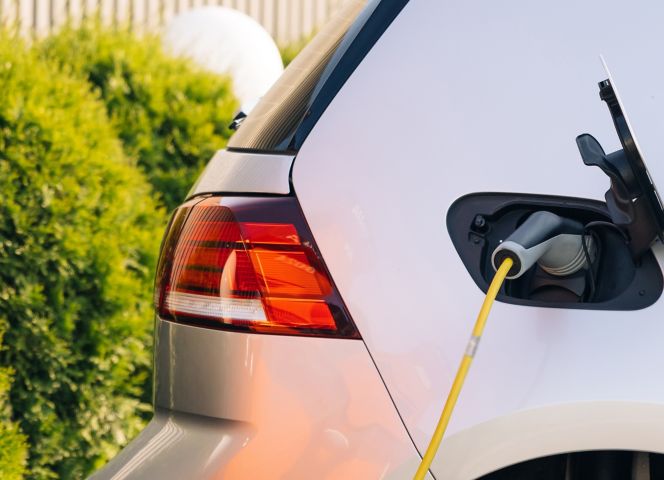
0 36 164 479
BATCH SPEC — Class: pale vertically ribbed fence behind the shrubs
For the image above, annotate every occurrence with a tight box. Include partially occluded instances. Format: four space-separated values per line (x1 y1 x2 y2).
0 0 344 44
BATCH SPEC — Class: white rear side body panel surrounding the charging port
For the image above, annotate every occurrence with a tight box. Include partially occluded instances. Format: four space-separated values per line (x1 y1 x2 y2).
292 0 664 478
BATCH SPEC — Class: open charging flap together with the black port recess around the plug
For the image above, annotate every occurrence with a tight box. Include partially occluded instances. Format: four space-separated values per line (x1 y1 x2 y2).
447 60 664 310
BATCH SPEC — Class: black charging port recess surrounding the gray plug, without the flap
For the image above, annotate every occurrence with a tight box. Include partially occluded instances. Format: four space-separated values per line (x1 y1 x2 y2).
447 193 664 310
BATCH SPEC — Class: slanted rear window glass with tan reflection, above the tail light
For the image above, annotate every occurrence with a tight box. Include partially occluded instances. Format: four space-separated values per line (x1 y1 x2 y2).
228 0 367 151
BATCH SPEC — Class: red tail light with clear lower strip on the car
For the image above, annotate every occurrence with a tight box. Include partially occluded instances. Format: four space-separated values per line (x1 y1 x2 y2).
155 196 360 338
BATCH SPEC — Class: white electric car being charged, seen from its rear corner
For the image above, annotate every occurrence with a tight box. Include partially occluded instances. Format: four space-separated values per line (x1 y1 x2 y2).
94 0 664 480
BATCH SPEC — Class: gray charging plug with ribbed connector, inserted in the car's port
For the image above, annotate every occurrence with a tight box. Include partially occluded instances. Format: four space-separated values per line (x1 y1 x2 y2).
491 211 595 280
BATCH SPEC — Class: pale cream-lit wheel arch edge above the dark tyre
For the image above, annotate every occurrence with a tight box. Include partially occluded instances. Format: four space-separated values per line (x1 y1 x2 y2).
433 401 664 479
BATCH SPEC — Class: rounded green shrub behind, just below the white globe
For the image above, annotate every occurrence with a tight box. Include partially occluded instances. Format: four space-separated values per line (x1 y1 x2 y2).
42 24 237 209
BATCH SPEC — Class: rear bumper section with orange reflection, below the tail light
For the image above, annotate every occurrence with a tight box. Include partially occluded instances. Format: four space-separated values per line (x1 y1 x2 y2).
94 320 420 480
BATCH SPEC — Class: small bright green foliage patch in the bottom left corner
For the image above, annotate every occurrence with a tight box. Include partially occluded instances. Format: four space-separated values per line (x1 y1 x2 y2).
0 324 28 480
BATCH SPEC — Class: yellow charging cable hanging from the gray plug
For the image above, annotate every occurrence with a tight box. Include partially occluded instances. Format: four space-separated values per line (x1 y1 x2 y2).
413 258 513 480
